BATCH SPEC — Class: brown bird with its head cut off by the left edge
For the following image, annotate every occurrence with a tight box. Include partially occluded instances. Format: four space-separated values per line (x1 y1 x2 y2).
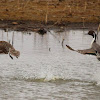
0 41 20 59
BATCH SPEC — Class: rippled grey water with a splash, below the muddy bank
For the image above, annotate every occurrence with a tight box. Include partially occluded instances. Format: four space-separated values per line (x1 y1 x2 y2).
0 29 100 100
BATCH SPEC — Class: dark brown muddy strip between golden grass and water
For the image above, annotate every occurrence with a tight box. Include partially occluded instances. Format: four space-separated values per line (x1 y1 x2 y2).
0 20 99 32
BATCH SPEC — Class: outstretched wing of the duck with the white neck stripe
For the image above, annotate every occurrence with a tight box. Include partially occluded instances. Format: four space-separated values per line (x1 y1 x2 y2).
66 45 96 56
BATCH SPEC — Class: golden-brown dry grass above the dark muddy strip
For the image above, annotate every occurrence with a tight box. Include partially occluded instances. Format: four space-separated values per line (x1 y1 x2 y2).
0 0 100 23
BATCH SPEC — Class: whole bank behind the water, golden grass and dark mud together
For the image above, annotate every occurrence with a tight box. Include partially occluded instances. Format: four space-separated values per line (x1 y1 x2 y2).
0 0 100 31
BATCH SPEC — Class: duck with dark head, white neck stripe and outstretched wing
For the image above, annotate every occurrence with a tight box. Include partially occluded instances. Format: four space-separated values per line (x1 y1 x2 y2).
66 31 100 61
